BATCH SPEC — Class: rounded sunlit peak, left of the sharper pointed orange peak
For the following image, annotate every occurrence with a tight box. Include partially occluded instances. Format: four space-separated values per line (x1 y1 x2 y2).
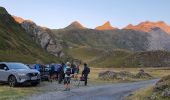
65 21 85 29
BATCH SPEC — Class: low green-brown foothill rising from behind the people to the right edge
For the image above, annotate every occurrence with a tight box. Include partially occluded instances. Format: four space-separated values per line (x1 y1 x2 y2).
89 50 170 67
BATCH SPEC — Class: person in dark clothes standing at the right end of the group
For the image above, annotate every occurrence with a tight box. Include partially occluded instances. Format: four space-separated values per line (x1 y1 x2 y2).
82 63 90 86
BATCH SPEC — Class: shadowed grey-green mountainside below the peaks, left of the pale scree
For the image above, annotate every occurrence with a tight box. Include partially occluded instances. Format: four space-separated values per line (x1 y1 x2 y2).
53 29 148 51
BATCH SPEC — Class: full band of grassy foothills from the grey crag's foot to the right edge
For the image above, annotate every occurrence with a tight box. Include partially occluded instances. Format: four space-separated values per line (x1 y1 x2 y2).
67 47 170 67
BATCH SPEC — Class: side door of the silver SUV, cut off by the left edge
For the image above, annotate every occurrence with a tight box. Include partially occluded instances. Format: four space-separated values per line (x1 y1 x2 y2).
0 64 9 81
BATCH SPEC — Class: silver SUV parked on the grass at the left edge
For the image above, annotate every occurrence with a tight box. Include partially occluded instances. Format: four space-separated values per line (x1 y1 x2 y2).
0 62 40 87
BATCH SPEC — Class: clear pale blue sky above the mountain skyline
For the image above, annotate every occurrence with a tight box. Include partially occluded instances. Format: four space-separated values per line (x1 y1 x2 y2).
0 0 170 29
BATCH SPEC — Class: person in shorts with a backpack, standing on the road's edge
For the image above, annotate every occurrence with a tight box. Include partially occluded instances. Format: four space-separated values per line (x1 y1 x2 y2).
64 62 72 91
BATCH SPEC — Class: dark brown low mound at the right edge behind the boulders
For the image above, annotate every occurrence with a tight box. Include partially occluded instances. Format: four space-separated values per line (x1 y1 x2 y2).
123 51 170 67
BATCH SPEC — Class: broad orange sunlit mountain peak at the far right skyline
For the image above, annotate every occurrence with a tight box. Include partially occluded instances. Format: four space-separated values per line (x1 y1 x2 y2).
125 21 170 33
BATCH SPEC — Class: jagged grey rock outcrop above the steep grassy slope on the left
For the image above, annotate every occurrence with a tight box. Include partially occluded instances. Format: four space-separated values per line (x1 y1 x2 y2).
21 20 65 57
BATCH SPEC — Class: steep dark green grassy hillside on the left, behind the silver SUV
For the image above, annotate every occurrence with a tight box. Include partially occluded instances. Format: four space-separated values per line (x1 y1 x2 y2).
0 7 59 63
